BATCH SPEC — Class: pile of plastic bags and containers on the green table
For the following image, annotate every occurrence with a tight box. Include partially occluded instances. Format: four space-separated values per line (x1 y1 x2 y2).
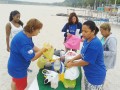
37 47 79 89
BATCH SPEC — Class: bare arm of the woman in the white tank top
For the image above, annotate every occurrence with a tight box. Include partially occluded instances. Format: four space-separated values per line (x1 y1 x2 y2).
6 23 11 52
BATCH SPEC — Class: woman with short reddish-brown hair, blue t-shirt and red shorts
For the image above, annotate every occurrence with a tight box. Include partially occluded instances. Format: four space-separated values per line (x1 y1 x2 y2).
8 19 47 90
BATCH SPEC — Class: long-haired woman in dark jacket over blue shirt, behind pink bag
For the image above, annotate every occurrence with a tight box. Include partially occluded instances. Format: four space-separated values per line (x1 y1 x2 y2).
62 12 82 51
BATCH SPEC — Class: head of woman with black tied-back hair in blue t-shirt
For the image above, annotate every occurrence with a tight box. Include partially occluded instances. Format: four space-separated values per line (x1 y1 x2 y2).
82 20 99 39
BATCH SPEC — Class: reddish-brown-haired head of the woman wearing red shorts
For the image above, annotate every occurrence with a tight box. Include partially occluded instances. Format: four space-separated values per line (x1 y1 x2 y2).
24 18 43 36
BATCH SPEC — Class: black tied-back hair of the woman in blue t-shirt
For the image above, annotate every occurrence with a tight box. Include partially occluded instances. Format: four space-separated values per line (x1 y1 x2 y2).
83 20 99 35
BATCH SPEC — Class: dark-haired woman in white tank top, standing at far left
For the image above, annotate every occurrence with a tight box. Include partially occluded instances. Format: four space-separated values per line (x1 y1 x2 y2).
6 10 23 52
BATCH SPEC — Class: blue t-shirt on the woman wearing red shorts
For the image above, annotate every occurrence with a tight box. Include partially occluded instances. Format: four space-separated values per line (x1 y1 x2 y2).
8 31 35 78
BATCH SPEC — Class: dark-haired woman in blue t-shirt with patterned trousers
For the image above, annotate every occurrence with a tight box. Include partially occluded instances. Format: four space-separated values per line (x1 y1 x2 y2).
66 21 106 90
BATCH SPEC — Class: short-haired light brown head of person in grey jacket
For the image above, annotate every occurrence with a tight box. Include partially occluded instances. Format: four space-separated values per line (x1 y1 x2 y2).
100 23 111 37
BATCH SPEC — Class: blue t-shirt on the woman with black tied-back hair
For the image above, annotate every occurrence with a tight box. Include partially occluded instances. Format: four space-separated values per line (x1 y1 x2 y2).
81 37 106 85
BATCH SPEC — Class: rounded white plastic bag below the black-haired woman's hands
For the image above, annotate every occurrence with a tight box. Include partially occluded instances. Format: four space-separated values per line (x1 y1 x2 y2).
64 67 80 80
